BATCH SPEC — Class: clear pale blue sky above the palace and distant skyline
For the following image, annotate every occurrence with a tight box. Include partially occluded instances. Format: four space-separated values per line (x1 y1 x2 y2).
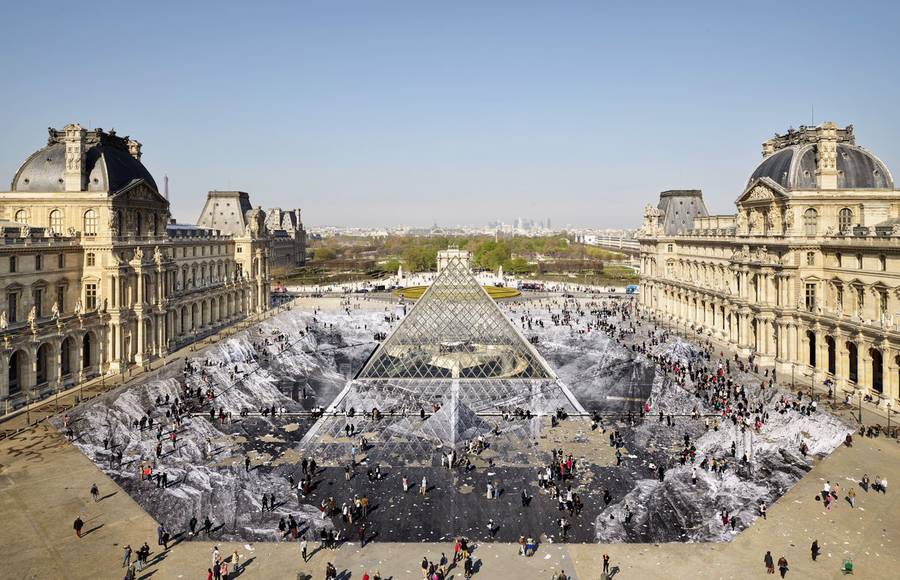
0 0 900 227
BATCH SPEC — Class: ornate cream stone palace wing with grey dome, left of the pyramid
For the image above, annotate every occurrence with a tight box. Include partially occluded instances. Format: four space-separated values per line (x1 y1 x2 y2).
0 124 305 406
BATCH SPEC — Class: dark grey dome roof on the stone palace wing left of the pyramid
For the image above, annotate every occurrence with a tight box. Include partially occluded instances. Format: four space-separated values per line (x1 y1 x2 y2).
10 143 158 192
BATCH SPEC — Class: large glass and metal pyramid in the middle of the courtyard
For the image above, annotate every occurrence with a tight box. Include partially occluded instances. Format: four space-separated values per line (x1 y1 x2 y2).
301 259 585 459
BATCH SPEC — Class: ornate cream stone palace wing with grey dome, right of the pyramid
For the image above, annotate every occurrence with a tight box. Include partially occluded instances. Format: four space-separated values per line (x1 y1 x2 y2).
639 123 900 405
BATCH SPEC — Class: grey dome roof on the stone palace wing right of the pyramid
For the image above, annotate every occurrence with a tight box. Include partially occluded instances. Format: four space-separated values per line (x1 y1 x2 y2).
750 143 894 189
